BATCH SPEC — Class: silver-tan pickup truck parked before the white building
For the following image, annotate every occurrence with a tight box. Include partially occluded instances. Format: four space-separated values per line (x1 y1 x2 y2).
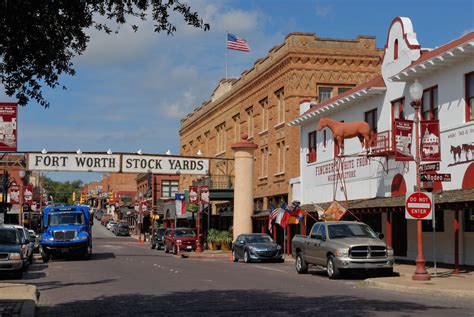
291 221 394 279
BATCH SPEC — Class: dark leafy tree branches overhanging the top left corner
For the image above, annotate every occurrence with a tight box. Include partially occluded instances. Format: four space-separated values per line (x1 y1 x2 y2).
0 0 209 108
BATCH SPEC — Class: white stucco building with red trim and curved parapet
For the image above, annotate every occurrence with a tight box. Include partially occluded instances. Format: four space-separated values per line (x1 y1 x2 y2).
289 17 474 265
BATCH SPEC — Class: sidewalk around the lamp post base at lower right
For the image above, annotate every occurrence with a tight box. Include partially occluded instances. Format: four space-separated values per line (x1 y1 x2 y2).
361 264 474 299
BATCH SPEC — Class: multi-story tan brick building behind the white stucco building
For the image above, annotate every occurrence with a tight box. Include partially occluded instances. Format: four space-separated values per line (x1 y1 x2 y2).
180 33 382 220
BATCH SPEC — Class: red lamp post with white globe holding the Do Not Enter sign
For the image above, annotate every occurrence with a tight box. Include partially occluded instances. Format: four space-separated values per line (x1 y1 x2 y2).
410 79 430 281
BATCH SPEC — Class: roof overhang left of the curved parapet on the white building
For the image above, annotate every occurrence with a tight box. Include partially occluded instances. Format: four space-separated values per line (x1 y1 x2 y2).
288 87 387 126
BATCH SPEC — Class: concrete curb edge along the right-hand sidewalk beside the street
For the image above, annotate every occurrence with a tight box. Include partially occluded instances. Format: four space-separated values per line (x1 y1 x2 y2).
359 279 474 299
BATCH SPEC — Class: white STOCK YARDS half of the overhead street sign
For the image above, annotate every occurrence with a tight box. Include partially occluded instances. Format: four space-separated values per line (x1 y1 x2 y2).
122 154 209 175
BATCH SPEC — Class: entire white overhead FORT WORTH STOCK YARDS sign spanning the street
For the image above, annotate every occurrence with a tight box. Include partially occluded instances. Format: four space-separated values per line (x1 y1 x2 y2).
27 153 209 175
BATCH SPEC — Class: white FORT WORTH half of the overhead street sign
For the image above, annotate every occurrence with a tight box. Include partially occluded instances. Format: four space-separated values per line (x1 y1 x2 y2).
27 153 120 173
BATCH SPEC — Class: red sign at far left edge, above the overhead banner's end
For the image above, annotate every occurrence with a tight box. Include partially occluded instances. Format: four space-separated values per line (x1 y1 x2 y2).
0 102 18 152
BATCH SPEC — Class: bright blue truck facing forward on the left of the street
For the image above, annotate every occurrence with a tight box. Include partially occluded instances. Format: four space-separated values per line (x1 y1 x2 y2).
40 206 93 263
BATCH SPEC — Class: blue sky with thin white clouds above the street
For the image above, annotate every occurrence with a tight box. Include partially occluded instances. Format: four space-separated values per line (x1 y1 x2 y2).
0 0 474 181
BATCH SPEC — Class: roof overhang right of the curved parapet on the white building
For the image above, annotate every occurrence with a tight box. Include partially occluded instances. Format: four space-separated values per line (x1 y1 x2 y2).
389 41 474 82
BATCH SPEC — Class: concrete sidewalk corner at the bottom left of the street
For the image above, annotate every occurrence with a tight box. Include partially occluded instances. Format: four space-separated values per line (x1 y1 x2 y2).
0 283 39 317
